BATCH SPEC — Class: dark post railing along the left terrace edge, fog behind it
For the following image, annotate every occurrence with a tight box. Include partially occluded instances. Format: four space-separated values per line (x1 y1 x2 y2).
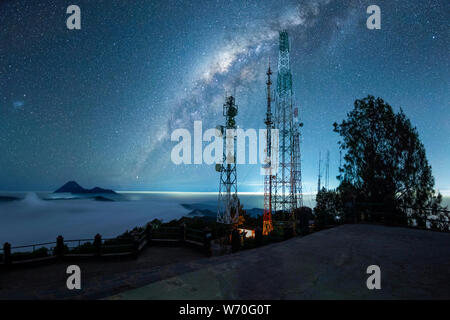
0 223 211 266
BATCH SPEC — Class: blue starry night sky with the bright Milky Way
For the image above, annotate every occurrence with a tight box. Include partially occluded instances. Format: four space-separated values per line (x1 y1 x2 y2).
0 0 450 194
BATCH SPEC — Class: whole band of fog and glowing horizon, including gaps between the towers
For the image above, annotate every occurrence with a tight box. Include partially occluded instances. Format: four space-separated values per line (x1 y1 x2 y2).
0 193 450 246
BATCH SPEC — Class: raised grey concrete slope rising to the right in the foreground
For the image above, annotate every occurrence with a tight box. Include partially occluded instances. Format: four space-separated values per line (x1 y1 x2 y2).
109 225 450 299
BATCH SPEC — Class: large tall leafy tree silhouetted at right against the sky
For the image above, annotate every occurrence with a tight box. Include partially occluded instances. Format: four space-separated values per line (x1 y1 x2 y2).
334 96 440 223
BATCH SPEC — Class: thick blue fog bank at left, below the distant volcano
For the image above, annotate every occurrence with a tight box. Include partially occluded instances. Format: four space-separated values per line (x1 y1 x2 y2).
0 193 189 246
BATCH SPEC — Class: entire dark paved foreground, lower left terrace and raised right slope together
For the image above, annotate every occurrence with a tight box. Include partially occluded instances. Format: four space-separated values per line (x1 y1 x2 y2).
0 224 450 299
